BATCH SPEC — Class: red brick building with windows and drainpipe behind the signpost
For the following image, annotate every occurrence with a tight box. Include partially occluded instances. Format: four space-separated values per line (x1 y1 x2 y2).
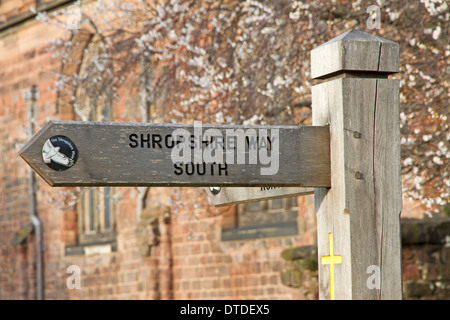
0 0 448 300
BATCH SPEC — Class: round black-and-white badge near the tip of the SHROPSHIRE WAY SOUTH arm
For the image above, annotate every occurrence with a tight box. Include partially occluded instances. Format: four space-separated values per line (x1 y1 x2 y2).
42 136 78 171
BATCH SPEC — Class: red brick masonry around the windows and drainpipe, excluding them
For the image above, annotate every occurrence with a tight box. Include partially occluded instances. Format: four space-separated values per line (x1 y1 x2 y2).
0 15 314 299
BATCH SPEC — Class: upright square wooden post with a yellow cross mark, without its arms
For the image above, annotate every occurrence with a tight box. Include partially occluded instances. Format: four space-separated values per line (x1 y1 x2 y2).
311 30 402 299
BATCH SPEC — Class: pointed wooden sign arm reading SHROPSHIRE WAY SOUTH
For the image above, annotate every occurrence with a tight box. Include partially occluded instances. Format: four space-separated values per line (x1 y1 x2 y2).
20 121 330 187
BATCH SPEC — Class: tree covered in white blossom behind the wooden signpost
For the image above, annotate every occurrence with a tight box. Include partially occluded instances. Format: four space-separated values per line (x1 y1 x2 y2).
38 0 450 214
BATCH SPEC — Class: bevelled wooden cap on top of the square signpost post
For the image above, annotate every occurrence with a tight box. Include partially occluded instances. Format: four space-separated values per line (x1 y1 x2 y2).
311 29 399 79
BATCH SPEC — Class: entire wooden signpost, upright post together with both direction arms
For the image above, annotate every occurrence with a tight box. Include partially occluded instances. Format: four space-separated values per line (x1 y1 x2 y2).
20 30 402 299
